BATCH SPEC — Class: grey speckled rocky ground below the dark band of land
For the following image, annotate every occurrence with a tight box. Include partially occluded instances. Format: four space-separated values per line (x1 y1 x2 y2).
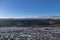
0 27 60 40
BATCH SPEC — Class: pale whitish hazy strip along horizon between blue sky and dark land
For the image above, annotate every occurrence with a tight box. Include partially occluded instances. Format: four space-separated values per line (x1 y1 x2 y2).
0 16 60 19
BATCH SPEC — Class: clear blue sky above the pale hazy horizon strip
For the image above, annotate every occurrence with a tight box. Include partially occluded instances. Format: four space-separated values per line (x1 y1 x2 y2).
0 0 60 17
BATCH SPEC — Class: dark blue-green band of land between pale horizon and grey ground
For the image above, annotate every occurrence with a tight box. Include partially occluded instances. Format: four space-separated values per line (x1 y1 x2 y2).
0 19 60 27
